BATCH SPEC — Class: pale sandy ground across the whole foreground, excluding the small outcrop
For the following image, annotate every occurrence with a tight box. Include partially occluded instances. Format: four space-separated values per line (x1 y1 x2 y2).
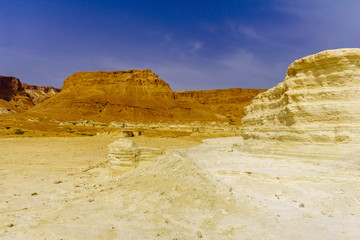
0 135 360 240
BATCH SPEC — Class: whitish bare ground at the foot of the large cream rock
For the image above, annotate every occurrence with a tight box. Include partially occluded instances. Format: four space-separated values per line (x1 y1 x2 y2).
183 138 360 240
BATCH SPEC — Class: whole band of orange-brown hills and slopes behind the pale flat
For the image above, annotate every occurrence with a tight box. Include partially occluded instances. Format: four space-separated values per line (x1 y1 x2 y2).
0 70 264 137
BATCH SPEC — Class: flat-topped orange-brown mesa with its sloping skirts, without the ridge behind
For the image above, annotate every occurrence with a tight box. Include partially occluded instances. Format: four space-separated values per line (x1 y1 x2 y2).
31 70 227 122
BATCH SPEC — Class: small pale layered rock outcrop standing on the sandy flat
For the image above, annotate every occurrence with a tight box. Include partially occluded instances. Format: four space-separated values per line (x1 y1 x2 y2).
108 138 165 170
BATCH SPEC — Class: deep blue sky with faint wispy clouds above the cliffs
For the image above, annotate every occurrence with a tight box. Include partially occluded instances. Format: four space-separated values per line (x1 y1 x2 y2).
0 0 360 91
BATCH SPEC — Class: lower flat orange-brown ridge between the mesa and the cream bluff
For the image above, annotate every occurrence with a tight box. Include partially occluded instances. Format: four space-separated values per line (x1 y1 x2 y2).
175 88 266 123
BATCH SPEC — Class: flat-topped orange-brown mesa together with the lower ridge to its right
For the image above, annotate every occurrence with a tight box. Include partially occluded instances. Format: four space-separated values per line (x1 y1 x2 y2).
31 70 263 123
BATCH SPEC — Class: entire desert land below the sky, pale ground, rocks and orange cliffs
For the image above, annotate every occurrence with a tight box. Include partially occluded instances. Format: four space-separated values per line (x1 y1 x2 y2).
0 49 360 239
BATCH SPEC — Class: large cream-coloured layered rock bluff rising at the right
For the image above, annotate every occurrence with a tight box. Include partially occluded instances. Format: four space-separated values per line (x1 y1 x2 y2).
242 49 360 160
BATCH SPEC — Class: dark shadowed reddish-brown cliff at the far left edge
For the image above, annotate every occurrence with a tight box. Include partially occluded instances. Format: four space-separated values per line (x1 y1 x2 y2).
0 76 34 114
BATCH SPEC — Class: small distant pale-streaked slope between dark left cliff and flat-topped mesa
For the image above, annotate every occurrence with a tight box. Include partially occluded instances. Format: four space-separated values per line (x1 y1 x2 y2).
22 83 61 105
